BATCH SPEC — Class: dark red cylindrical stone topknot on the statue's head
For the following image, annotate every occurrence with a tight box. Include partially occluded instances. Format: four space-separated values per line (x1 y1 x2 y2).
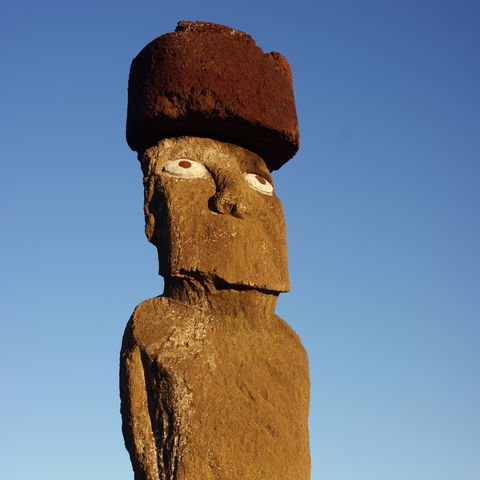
127 22 299 170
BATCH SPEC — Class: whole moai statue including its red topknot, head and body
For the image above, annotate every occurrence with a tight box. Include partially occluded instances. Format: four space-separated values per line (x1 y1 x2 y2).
120 22 310 480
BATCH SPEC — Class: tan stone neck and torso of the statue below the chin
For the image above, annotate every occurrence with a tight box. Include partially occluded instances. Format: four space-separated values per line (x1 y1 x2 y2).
121 284 310 480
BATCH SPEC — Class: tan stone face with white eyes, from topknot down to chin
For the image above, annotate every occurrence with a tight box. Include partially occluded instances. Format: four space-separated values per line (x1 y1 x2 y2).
140 137 289 292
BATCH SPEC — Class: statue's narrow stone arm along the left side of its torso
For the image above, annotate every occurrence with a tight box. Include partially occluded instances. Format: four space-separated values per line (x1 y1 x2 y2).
120 320 159 480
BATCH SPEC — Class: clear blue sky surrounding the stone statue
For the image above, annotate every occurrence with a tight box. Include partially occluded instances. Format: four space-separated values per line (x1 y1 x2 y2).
0 0 480 480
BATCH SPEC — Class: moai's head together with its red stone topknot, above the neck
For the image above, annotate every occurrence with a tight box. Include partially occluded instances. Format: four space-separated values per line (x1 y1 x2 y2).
127 22 299 293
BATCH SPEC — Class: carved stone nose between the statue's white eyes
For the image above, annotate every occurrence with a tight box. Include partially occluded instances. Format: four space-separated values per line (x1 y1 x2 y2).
210 175 247 218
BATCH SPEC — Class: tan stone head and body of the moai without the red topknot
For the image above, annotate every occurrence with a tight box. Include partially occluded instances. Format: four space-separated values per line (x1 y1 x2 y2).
120 24 310 480
